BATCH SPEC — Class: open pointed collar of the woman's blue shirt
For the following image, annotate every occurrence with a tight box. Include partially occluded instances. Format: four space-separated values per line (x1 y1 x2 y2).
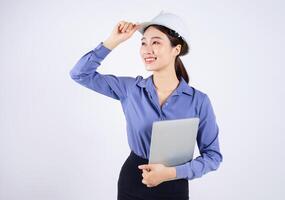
137 74 193 95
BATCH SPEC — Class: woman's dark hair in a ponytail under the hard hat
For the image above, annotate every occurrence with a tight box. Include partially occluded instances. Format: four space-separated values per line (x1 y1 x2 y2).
144 24 190 83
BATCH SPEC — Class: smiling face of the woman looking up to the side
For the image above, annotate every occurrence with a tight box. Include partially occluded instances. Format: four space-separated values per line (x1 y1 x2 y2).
140 26 181 71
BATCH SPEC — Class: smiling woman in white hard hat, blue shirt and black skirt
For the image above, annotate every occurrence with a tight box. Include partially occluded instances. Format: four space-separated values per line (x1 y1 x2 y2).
70 11 223 200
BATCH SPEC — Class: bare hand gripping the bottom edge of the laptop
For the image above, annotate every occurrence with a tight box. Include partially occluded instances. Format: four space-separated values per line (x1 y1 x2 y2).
138 164 176 187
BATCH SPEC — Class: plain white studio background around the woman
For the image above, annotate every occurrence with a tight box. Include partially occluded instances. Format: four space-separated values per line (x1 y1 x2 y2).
0 0 285 200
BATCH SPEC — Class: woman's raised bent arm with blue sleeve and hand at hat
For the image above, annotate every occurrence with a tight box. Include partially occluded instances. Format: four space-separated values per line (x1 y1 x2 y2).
69 22 139 101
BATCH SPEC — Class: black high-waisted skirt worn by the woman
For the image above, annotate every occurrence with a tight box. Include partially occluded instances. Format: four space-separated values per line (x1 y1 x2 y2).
117 151 189 200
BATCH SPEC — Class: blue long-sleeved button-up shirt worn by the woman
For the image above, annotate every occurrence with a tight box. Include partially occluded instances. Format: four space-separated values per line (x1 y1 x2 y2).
70 42 223 180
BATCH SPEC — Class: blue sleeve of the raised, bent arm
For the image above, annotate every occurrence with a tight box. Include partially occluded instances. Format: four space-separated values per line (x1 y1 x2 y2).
69 42 135 100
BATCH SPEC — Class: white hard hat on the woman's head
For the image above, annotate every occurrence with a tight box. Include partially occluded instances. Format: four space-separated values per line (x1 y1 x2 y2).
138 10 190 52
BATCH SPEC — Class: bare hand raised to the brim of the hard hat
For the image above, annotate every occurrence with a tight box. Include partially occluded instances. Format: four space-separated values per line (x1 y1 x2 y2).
104 21 140 49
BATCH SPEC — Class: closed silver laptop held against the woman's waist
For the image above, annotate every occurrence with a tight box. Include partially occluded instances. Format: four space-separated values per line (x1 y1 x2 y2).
149 117 199 167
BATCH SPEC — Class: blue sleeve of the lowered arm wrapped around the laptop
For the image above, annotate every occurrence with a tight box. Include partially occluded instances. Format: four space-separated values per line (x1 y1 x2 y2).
175 94 223 180
